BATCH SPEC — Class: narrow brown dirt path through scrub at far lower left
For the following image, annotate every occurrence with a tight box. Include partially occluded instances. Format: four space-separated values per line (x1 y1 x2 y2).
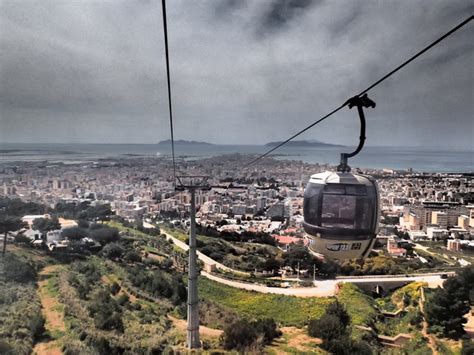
33 265 66 355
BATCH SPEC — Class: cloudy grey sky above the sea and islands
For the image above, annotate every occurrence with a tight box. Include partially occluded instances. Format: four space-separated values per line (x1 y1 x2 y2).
0 0 474 150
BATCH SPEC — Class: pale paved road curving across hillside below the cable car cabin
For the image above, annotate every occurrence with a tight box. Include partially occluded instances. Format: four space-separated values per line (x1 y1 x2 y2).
162 232 449 297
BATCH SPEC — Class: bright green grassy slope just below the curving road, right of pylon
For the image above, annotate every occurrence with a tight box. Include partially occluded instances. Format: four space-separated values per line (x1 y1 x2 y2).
199 277 331 327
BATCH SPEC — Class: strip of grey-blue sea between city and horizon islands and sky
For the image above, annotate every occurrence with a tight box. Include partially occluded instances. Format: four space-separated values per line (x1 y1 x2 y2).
0 143 474 173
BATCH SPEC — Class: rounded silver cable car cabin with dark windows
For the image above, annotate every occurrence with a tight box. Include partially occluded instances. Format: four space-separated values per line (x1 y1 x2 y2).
303 172 380 259
